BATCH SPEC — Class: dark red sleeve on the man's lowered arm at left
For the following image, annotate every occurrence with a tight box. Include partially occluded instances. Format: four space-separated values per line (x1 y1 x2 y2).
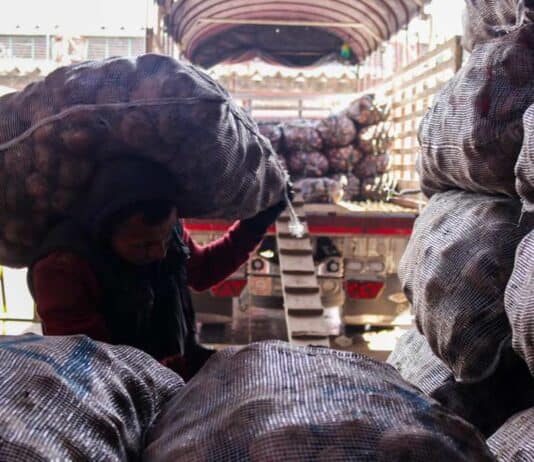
32 252 111 342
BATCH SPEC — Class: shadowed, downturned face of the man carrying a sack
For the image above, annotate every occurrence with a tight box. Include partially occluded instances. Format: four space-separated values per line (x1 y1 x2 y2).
111 209 178 265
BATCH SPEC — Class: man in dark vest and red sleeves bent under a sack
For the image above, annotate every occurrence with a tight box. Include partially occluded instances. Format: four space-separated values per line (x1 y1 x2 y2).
29 158 286 379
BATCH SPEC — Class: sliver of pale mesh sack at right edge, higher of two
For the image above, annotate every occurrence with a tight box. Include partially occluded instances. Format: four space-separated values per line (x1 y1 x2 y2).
515 105 534 213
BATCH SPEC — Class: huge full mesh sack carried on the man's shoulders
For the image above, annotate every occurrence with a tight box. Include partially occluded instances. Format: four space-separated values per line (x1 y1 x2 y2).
0 54 285 266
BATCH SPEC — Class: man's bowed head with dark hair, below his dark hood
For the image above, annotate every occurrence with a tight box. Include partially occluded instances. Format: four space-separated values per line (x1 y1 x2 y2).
105 201 178 265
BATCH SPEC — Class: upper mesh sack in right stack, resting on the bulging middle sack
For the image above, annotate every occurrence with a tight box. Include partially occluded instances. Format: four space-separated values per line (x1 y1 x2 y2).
417 25 534 196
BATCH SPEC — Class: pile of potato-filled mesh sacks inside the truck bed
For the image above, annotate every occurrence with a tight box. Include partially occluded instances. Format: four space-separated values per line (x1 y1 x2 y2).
259 96 391 200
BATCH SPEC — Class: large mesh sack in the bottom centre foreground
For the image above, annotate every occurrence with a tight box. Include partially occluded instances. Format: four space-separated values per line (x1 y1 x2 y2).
144 342 493 462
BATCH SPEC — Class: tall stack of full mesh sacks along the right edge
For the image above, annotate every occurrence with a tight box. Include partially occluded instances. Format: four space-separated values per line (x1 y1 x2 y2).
390 0 534 460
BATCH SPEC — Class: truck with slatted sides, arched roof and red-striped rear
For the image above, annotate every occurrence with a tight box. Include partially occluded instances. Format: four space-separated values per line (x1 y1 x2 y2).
147 1 463 346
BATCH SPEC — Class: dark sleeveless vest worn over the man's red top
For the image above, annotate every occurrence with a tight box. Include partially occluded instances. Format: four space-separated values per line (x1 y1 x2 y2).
28 221 196 359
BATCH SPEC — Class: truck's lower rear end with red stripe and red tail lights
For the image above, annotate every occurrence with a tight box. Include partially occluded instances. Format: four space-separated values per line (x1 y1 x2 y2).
185 203 418 344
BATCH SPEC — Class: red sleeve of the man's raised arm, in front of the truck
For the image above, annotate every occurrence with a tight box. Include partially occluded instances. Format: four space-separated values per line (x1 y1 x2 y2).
184 221 263 291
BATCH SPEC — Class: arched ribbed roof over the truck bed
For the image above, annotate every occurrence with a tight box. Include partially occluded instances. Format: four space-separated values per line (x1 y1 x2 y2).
166 0 428 67
